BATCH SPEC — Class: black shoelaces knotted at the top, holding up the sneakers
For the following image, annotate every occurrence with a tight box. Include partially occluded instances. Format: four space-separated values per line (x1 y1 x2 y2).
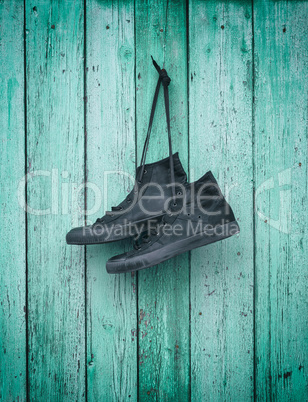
96 56 175 223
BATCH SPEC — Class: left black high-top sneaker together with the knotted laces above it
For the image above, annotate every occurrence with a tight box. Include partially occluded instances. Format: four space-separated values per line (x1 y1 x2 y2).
66 58 187 244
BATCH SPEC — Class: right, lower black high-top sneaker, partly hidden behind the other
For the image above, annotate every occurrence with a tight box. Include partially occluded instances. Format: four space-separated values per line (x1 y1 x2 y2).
106 172 240 274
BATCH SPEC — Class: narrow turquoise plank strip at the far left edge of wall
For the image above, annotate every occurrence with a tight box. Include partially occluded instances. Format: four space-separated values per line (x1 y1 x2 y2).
0 1 26 401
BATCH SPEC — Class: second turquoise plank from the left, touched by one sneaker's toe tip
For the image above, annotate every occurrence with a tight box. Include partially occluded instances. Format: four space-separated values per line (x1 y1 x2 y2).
26 0 85 400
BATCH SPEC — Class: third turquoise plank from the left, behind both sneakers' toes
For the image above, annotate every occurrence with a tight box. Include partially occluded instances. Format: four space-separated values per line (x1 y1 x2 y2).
86 1 137 401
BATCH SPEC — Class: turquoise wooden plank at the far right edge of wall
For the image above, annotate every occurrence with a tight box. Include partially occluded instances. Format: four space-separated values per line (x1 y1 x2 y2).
254 0 308 401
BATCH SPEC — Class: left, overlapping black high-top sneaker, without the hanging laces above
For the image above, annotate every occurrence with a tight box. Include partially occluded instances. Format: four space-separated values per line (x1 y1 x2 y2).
66 153 187 244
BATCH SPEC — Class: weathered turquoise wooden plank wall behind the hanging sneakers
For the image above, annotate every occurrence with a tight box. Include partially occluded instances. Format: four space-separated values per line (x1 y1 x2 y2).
0 0 308 402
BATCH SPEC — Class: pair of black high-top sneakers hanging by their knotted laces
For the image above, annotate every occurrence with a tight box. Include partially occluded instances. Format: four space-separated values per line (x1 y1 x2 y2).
66 58 240 274
